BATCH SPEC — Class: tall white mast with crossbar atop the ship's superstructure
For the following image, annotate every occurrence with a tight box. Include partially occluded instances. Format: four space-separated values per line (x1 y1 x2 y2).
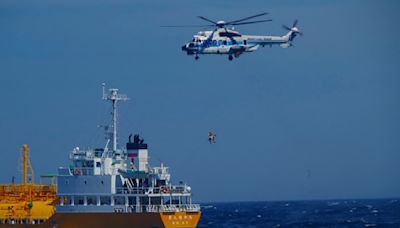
103 83 129 151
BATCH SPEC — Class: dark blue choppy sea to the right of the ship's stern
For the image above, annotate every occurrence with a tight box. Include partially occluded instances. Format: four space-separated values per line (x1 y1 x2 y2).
198 199 400 228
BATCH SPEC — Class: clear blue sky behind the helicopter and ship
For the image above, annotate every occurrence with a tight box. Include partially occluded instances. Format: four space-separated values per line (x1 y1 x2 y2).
0 0 400 202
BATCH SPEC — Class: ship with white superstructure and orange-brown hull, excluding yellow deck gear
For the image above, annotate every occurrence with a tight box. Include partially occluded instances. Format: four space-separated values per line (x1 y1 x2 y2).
0 84 201 228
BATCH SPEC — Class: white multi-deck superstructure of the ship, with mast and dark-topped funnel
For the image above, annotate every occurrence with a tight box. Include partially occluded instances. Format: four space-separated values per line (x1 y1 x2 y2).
57 87 200 219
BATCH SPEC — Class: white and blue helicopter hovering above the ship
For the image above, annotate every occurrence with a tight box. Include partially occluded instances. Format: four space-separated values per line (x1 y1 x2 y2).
162 12 303 61
